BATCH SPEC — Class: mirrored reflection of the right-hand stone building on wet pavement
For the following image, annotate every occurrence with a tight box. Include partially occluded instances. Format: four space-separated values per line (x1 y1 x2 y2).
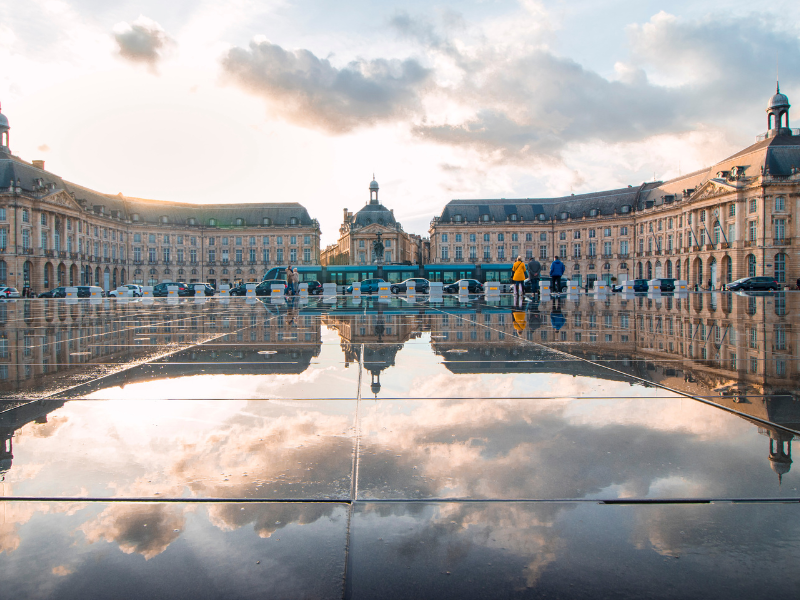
422 293 800 482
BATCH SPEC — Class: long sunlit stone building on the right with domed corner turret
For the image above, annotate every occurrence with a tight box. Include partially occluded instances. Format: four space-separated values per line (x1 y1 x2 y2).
430 85 800 289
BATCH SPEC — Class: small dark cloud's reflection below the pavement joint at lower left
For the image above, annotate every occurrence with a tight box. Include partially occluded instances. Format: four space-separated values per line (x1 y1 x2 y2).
81 504 185 560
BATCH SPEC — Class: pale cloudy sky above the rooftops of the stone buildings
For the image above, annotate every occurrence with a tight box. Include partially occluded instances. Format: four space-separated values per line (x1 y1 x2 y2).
0 0 800 244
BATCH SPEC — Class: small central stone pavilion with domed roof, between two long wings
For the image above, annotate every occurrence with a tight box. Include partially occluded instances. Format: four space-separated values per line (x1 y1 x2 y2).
321 179 426 265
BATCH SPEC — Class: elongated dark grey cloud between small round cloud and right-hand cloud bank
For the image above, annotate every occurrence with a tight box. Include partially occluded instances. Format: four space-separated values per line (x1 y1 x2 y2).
222 41 430 133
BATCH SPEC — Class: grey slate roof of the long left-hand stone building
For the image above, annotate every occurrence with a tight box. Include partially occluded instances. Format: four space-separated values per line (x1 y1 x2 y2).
0 151 318 227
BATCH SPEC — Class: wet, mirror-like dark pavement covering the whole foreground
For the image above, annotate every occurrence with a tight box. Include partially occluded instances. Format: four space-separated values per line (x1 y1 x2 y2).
0 292 800 599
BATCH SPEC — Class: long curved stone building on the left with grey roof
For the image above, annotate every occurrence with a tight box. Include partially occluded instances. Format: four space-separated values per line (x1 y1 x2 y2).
0 108 320 292
